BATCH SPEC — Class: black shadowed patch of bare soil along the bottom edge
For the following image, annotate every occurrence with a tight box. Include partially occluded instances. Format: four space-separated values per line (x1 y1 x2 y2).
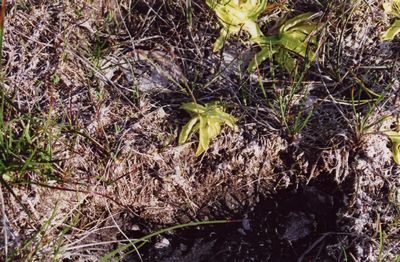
126 177 345 261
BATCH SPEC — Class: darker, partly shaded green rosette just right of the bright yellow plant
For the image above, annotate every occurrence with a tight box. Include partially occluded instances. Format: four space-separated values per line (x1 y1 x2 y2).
248 13 321 73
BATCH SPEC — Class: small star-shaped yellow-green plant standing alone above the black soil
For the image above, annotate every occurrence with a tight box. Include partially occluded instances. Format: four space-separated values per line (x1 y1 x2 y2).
179 102 236 156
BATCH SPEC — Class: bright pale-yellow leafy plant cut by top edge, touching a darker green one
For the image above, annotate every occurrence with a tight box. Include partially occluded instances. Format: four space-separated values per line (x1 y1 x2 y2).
207 0 267 52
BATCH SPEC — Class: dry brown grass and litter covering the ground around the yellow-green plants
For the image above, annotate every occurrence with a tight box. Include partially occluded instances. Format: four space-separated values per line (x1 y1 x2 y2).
0 0 400 261
